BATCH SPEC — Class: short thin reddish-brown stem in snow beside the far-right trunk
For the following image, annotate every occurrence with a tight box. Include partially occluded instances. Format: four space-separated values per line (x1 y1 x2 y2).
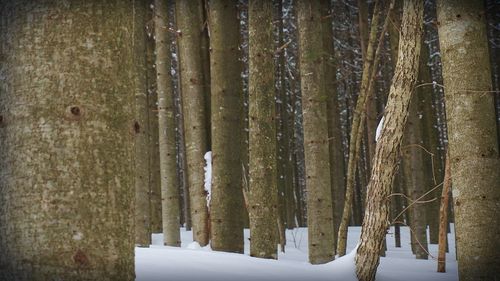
437 153 451 272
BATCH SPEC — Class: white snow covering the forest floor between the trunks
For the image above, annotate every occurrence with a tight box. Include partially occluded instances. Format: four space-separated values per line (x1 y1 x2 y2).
135 227 458 281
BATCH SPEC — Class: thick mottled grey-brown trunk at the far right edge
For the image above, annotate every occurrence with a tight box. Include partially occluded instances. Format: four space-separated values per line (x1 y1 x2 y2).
437 0 500 280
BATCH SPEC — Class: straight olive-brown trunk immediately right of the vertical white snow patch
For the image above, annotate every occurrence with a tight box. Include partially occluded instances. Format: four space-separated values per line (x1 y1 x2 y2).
209 0 243 253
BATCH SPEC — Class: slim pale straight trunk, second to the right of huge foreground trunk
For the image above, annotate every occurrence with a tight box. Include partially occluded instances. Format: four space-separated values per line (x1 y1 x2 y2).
153 0 181 246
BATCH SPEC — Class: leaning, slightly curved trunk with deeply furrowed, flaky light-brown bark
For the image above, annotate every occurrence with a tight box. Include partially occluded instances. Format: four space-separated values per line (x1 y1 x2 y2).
356 0 424 281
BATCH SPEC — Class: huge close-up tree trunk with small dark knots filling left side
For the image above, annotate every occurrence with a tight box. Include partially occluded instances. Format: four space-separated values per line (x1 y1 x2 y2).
0 0 139 281
